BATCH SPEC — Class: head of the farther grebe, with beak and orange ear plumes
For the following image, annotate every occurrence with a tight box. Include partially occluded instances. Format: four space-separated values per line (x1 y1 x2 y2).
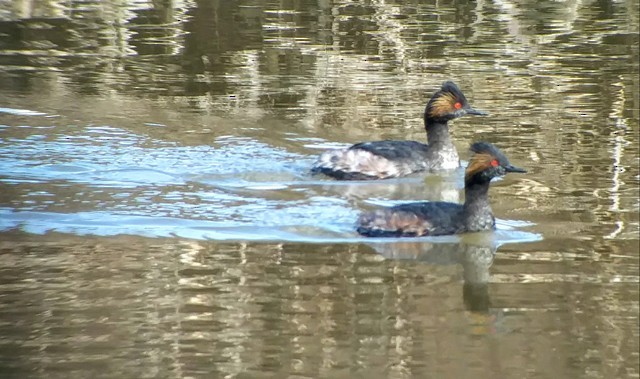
424 82 488 122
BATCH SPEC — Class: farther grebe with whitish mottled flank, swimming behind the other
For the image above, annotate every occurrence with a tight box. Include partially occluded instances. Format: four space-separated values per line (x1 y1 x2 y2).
311 82 488 180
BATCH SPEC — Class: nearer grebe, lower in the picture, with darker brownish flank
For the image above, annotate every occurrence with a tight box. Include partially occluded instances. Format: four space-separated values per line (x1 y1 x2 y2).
357 142 526 237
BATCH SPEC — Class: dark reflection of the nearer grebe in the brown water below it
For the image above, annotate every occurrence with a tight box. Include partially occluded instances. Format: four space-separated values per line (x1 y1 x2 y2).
369 232 503 335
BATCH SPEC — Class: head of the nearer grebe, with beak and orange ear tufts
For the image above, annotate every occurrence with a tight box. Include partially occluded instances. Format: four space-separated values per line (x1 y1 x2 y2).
464 142 526 182
